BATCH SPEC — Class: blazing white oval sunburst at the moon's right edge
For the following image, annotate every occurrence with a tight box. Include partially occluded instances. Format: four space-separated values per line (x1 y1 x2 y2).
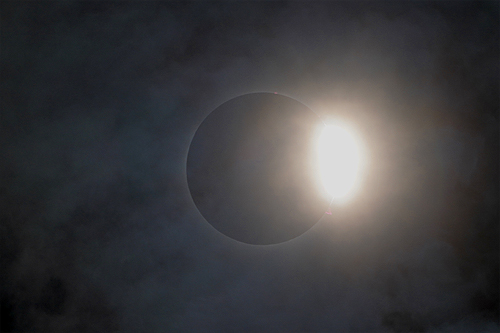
316 123 362 201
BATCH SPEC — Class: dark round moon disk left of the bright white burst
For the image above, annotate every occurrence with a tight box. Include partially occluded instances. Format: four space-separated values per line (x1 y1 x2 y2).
187 93 328 245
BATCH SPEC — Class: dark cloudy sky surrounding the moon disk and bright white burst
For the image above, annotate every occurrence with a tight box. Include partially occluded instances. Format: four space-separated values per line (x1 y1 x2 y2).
0 1 500 332
